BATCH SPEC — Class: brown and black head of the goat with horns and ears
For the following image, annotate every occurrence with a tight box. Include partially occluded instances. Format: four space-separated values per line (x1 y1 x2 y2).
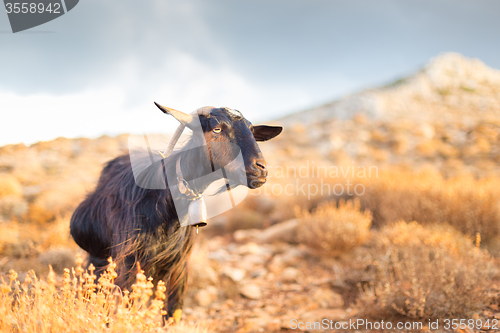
155 103 283 188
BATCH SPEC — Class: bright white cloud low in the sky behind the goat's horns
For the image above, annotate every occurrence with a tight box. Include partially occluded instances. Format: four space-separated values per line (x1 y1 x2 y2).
0 53 312 145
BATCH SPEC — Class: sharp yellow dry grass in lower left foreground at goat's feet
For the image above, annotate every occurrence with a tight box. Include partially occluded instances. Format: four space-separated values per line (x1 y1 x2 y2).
0 254 211 332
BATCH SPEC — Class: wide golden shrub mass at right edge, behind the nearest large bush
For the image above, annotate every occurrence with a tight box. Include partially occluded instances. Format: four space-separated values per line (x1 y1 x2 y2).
360 169 500 240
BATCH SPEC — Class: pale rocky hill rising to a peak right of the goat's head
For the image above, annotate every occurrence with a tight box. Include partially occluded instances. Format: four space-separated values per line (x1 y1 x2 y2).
279 53 500 175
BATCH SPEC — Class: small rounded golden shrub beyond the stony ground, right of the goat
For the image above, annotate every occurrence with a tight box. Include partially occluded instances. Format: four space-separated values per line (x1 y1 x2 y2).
297 199 372 255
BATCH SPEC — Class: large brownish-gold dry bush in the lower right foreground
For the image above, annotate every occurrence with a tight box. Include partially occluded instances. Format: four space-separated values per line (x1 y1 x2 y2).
358 221 497 320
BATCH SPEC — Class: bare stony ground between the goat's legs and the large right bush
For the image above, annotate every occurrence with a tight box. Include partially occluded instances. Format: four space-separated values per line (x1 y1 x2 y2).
184 228 356 332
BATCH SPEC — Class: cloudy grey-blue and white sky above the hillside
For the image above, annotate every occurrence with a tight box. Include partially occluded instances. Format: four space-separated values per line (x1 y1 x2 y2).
0 0 500 145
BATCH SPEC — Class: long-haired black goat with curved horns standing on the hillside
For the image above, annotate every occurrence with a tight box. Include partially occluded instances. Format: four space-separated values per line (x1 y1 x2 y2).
71 103 282 320
